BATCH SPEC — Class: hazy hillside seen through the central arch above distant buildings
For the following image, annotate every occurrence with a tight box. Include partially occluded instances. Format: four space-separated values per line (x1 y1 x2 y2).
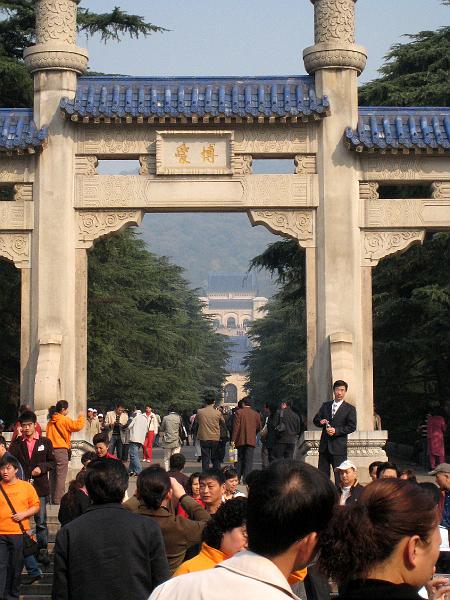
139 213 278 296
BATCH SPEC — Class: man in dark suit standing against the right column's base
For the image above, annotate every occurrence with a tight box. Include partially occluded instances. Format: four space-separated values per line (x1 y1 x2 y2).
313 379 356 485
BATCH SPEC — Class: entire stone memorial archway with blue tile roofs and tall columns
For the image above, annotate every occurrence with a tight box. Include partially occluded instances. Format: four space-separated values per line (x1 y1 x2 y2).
0 0 450 466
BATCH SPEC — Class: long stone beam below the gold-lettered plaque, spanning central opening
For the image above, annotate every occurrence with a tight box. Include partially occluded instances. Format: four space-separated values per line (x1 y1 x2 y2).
75 175 318 211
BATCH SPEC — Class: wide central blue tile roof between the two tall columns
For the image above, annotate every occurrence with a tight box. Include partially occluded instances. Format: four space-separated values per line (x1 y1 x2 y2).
61 76 329 121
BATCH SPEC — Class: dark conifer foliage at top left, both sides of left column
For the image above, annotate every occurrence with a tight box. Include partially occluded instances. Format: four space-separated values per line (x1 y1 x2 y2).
0 0 167 108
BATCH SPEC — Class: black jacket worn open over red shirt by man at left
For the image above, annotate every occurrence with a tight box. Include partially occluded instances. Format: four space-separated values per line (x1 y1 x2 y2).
8 437 56 497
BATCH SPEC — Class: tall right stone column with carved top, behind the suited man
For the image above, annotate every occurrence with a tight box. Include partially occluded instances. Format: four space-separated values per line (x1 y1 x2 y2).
303 0 383 474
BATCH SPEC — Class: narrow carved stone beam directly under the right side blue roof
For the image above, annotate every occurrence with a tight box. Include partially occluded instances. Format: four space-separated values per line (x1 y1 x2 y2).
360 154 450 183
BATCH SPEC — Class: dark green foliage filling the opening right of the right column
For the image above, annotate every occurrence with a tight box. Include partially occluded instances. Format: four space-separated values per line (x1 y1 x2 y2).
373 233 450 442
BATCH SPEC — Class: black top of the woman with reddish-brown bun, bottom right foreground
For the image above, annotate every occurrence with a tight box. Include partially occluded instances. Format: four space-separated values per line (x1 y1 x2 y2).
338 579 420 600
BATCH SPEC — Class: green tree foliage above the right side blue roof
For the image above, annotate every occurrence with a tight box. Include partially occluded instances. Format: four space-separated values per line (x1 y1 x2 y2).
359 27 450 106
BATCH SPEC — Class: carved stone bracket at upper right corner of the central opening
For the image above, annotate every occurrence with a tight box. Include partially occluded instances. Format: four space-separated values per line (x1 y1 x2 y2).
248 210 315 248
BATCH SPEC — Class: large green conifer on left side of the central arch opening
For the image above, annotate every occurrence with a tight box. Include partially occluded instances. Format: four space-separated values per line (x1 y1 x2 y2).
88 230 227 418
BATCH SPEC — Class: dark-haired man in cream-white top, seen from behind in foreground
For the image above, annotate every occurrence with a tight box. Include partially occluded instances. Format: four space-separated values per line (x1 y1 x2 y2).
150 460 337 600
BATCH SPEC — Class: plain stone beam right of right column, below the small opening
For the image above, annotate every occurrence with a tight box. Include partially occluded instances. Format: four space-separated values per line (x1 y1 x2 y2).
362 200 450 230
